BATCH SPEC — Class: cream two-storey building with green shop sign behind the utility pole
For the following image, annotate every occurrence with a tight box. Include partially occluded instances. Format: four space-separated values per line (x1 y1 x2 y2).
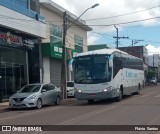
40 0 92 86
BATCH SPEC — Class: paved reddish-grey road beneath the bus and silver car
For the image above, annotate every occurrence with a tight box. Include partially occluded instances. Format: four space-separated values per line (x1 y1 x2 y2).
0 86 160 134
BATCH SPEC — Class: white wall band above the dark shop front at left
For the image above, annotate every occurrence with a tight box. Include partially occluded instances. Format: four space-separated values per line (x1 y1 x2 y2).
0 6 46 38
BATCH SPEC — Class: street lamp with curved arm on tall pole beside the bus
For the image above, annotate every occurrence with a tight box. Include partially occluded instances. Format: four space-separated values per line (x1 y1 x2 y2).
61 4 99 99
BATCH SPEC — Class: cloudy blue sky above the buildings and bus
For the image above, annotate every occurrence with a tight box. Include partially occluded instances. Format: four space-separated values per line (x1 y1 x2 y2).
52 0 160 55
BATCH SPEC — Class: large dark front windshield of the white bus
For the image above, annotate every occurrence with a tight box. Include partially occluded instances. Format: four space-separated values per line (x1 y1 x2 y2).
74 55 112 84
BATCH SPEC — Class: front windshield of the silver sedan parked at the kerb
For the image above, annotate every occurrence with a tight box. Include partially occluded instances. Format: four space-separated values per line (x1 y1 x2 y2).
18 85 41 93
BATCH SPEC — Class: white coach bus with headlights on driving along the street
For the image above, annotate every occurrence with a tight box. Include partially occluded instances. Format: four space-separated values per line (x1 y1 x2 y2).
74 49 144 103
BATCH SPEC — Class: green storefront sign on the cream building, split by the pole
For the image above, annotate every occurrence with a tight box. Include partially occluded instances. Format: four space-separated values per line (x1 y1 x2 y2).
42 42 78 60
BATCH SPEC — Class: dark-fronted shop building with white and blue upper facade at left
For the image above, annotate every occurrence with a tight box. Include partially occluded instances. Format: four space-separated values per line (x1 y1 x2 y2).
0 0 46 102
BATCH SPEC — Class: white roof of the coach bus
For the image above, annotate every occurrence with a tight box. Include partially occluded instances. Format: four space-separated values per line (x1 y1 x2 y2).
75 48 128 57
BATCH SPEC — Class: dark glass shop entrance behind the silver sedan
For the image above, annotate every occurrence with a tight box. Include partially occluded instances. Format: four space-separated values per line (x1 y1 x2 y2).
0 48 27 101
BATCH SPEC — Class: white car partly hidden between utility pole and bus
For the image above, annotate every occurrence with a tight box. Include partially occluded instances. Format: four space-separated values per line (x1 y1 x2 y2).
67 81 75 97
